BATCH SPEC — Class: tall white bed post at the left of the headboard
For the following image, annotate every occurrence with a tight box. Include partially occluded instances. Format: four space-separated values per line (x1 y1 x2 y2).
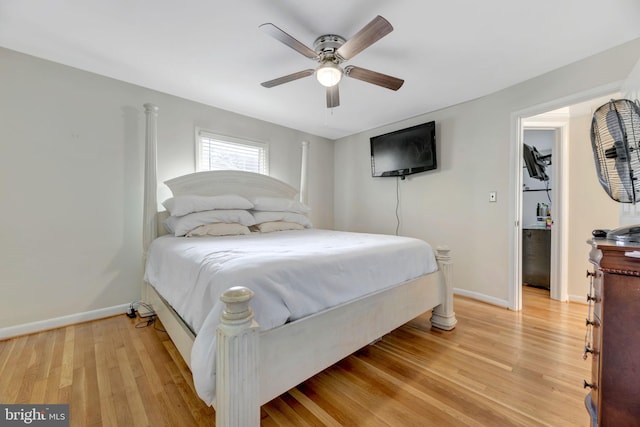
142 103 158 257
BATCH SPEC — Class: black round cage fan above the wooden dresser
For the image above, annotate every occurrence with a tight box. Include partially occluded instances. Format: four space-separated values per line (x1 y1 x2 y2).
591 99 640 242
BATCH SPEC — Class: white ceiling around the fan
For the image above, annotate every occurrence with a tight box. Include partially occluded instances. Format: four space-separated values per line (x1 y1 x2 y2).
0 0 640 139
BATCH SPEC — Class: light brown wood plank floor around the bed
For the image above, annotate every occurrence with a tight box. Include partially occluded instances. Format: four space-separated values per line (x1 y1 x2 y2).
0 288 590 426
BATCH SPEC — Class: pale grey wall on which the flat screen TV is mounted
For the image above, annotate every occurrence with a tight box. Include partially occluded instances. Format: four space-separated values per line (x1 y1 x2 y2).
335 39 640 305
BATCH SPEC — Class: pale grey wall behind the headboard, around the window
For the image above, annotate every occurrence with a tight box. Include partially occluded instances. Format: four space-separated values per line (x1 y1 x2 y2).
0 48 334 335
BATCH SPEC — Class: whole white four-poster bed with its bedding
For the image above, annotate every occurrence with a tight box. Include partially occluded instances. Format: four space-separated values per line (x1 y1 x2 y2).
143 104 456 427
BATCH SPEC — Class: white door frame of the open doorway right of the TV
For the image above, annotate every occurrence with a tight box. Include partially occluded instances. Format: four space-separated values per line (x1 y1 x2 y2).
508 82 622 311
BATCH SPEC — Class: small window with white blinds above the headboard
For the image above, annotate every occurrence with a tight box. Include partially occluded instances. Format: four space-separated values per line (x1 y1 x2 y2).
196 128 269 175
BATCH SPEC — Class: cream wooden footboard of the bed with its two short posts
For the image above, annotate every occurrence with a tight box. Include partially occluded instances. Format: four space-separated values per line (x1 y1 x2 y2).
214 248 456 427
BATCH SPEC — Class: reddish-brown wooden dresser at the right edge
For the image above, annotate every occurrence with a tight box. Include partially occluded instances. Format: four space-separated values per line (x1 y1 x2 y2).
584 239 640 427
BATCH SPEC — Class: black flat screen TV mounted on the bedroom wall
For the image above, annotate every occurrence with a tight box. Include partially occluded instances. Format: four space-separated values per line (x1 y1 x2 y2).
370 122 438 177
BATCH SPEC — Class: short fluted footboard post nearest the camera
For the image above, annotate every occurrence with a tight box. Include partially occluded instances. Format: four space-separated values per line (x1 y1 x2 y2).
215 286 260 427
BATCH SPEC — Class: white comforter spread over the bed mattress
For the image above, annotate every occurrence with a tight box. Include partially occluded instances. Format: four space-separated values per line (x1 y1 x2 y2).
145 229 437 404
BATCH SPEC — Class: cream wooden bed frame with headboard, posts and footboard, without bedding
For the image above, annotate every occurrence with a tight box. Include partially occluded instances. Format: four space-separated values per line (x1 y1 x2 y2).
142 104 456 427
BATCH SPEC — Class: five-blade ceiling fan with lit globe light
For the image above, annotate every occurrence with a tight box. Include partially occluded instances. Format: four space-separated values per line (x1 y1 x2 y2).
259 16 404 108
